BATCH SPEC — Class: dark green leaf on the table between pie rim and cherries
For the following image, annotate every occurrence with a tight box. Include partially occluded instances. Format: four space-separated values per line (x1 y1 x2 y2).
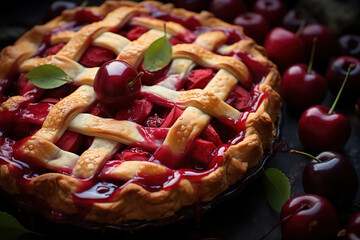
262 168 290 212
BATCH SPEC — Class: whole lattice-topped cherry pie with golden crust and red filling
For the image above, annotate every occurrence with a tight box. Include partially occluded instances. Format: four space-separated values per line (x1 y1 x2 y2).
0 1 281 225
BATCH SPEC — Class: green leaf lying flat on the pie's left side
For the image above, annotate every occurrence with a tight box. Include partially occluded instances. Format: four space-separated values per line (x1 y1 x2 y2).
25 64 71 89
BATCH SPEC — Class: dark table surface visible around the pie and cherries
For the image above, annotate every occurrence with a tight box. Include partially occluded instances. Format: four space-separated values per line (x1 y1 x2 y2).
0 1 360 240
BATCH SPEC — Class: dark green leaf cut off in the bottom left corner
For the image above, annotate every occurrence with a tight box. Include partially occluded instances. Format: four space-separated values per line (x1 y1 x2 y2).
0 211 32 239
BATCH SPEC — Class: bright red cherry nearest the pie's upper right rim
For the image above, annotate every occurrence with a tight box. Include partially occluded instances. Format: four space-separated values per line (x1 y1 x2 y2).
264 27 306 71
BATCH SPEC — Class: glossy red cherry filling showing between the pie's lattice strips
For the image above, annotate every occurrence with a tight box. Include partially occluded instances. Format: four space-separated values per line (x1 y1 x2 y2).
0 4 268 209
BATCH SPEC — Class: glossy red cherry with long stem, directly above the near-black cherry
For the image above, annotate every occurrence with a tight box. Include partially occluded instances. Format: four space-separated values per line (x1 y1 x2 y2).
298 105 351 152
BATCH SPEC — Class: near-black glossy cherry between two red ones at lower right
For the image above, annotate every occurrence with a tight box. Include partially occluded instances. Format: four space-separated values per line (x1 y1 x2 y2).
302 151 359 208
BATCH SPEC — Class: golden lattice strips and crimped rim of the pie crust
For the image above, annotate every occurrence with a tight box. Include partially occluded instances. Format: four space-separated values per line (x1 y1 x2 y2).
0 1 280 224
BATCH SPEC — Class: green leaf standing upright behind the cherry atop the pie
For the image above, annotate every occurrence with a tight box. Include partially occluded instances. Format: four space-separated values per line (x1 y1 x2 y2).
144 33 172 72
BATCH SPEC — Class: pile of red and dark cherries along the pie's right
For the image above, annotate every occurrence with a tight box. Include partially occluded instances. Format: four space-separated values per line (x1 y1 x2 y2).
169 0 360 239
